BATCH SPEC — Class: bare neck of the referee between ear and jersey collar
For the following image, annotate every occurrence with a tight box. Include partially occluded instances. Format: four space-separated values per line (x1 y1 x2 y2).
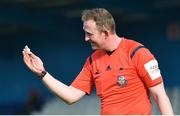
106 34 122 52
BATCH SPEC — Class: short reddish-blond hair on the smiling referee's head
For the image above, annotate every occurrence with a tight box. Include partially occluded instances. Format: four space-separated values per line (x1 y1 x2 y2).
81 8 115 33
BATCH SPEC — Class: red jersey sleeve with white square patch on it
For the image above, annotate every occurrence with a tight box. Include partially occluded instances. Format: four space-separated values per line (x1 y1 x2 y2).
132 48 163 88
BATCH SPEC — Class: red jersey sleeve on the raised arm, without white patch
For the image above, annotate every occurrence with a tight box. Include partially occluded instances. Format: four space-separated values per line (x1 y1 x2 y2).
71 58 94 94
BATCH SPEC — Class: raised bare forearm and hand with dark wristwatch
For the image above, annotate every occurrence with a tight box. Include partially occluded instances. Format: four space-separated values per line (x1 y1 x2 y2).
23 46 85 104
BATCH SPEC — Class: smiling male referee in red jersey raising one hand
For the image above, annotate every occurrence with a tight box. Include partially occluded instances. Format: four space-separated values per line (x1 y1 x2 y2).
23 8 173 115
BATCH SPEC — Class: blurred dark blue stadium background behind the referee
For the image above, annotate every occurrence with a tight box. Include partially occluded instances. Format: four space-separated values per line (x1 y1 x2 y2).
0 0 180 115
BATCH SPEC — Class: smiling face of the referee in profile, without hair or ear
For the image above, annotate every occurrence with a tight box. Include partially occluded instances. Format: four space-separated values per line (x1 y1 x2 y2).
83 20 105 50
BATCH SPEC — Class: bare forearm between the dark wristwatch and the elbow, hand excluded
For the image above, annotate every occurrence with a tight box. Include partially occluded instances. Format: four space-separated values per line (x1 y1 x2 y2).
42 73 85 104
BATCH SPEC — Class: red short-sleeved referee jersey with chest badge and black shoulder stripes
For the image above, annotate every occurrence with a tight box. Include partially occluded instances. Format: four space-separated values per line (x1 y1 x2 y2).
71 38 162 115
